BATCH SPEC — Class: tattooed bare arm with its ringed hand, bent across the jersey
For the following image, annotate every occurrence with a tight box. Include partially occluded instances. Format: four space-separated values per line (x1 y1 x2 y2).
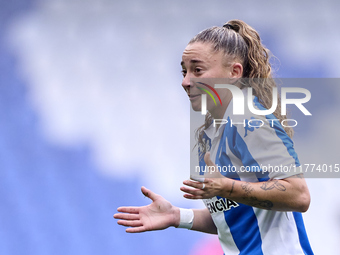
181 153 310 212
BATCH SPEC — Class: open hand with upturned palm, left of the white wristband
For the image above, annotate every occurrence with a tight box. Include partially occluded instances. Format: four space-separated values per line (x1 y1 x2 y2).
113 187 180 233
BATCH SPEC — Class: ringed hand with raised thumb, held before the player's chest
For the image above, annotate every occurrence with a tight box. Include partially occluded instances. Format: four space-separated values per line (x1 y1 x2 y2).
180 152 232 199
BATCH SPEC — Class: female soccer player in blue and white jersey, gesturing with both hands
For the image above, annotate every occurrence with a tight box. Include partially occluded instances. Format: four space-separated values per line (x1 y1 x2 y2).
114 20 313 255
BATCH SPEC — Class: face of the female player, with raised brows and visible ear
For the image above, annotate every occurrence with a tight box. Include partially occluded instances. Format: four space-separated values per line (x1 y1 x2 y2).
181 42 242 117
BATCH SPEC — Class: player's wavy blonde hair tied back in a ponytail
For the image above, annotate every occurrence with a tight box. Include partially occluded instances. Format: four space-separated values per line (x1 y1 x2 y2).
189 20 294 153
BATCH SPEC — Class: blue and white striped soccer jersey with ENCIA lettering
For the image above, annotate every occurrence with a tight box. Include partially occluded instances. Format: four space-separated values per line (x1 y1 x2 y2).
200 90 313 255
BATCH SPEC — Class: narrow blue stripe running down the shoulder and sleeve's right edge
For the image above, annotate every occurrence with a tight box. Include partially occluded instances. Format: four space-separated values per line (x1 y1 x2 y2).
254 97 300 166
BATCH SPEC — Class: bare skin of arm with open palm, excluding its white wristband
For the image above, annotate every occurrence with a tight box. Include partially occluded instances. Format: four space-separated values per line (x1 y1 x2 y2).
113 187 217 234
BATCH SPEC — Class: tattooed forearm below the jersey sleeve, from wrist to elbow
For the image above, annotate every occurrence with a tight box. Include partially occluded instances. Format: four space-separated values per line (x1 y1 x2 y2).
221 174 310 212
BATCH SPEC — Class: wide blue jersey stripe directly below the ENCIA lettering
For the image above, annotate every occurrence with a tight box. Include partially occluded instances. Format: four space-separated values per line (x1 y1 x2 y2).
224 204 263 255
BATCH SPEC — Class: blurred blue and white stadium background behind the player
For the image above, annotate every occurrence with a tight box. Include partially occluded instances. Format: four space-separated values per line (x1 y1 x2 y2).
0 0 340 255
